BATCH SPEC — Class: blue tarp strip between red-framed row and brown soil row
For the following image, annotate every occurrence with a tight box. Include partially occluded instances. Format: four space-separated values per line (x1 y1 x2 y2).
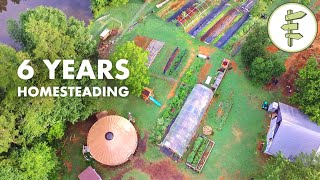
189 0 229 37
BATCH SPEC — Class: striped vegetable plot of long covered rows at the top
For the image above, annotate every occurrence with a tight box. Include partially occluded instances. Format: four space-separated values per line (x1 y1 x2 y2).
159 0 255 48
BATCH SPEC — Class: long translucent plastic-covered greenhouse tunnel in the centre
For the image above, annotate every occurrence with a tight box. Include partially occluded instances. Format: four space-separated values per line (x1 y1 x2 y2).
161 84 213 157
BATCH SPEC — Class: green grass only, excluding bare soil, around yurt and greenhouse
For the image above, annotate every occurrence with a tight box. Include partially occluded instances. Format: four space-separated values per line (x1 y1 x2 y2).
61 0 288 179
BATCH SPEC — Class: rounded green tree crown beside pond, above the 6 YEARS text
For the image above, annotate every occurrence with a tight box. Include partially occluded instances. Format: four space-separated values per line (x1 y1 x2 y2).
8 6 96 60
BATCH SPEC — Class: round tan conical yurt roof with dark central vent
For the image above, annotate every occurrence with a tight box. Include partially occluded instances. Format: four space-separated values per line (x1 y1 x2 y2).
87 115 138 166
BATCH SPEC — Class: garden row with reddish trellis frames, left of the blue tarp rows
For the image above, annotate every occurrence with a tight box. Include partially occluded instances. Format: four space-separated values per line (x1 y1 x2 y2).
177 0 213 29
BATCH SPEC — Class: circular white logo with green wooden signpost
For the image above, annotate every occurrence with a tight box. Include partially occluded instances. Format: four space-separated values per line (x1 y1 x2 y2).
268 3 318 52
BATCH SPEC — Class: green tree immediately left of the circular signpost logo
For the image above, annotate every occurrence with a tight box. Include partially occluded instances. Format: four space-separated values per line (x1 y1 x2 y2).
241 26 269 67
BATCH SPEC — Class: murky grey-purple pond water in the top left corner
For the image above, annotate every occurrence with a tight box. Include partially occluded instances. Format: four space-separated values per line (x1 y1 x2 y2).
0 0 92 48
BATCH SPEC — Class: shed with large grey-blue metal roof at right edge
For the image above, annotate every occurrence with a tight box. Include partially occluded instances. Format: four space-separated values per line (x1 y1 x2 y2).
265 103 320 160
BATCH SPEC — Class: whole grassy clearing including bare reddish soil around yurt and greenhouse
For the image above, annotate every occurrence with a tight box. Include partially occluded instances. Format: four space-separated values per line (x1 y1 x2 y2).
60 0 281 179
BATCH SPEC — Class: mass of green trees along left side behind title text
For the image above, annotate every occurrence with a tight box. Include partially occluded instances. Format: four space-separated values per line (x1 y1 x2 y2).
0 7 100 179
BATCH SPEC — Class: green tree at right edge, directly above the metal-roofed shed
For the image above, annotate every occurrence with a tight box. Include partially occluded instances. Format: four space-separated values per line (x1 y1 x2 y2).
291 58 320 125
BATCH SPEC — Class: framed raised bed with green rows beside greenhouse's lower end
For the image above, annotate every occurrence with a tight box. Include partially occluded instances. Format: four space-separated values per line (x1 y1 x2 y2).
186 136 215 173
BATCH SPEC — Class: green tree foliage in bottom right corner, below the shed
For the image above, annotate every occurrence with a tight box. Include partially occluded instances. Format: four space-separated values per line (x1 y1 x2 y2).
257 152 320 179
